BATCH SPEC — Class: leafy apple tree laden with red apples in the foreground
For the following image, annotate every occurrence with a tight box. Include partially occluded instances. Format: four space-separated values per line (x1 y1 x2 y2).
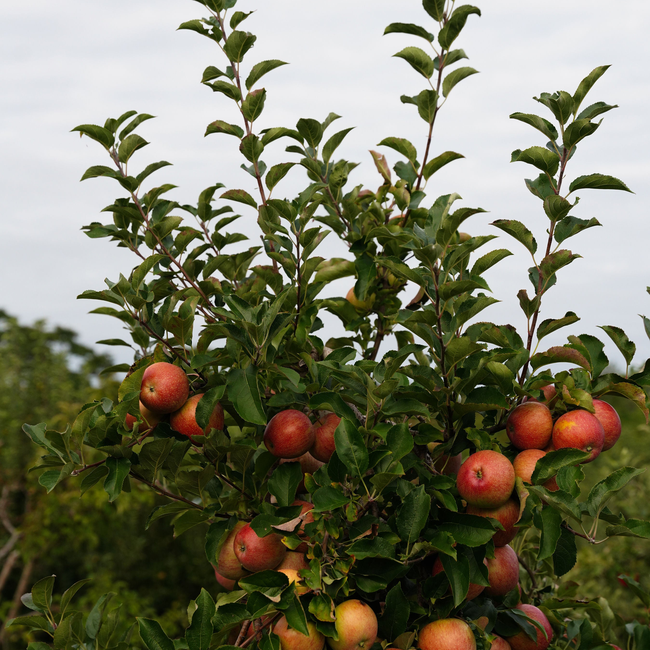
12 0 650 650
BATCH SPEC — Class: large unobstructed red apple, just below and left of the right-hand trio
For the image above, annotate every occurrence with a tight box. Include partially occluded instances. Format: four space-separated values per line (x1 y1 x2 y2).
456 449 515 508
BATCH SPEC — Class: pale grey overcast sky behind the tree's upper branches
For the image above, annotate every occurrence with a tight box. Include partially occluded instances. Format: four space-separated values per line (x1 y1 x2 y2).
0 0 650 370
